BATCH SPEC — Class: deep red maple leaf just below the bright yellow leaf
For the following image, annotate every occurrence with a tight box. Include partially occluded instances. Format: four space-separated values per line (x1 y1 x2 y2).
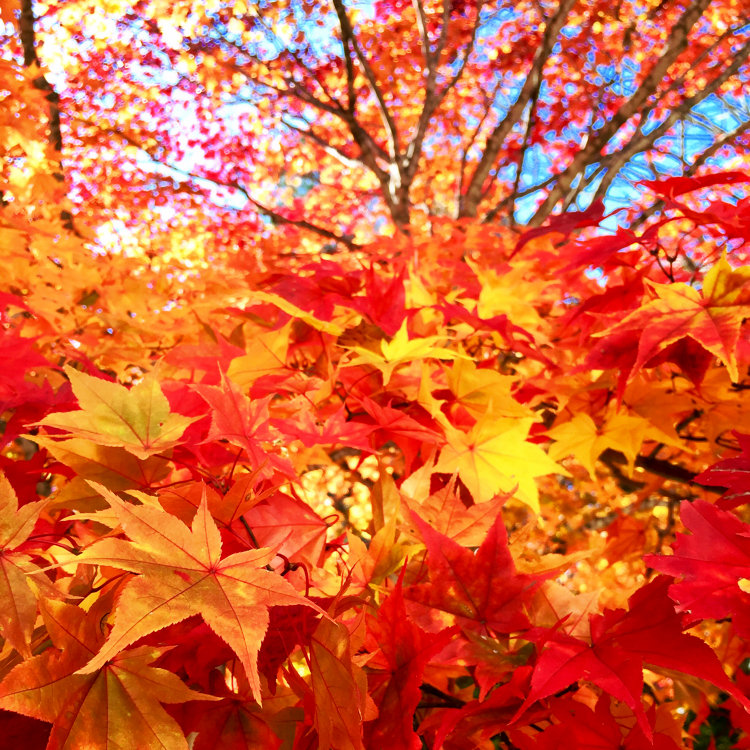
405 514 542 633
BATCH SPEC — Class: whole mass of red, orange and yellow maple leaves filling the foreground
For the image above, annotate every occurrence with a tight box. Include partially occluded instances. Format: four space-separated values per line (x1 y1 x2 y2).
0 175 750 750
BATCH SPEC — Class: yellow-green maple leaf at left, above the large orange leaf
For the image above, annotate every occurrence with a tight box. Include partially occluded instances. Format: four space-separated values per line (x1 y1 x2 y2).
37 366 195 459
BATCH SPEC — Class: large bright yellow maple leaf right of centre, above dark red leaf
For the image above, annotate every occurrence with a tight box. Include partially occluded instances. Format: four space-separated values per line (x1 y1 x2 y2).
435 417 567 513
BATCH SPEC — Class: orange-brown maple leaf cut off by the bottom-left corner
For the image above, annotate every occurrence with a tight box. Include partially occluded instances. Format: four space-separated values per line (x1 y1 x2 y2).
0 600 216 750
